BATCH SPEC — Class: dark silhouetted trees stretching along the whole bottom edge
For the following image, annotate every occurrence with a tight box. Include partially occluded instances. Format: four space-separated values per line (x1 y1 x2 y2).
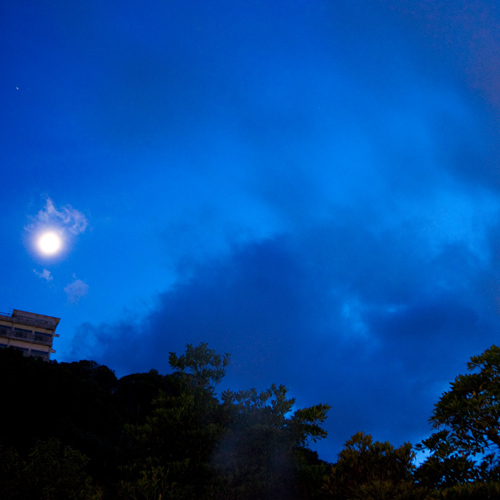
4 344 500 500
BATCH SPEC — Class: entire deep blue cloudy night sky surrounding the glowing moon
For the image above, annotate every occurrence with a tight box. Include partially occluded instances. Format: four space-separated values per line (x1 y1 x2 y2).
0 0 500 461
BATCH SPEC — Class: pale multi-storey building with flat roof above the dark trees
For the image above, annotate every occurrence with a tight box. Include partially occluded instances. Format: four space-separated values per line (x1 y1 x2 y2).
0 309 59 361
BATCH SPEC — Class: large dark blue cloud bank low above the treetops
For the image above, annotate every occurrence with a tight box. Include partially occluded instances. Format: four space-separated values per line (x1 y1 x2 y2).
74 208 498 459
